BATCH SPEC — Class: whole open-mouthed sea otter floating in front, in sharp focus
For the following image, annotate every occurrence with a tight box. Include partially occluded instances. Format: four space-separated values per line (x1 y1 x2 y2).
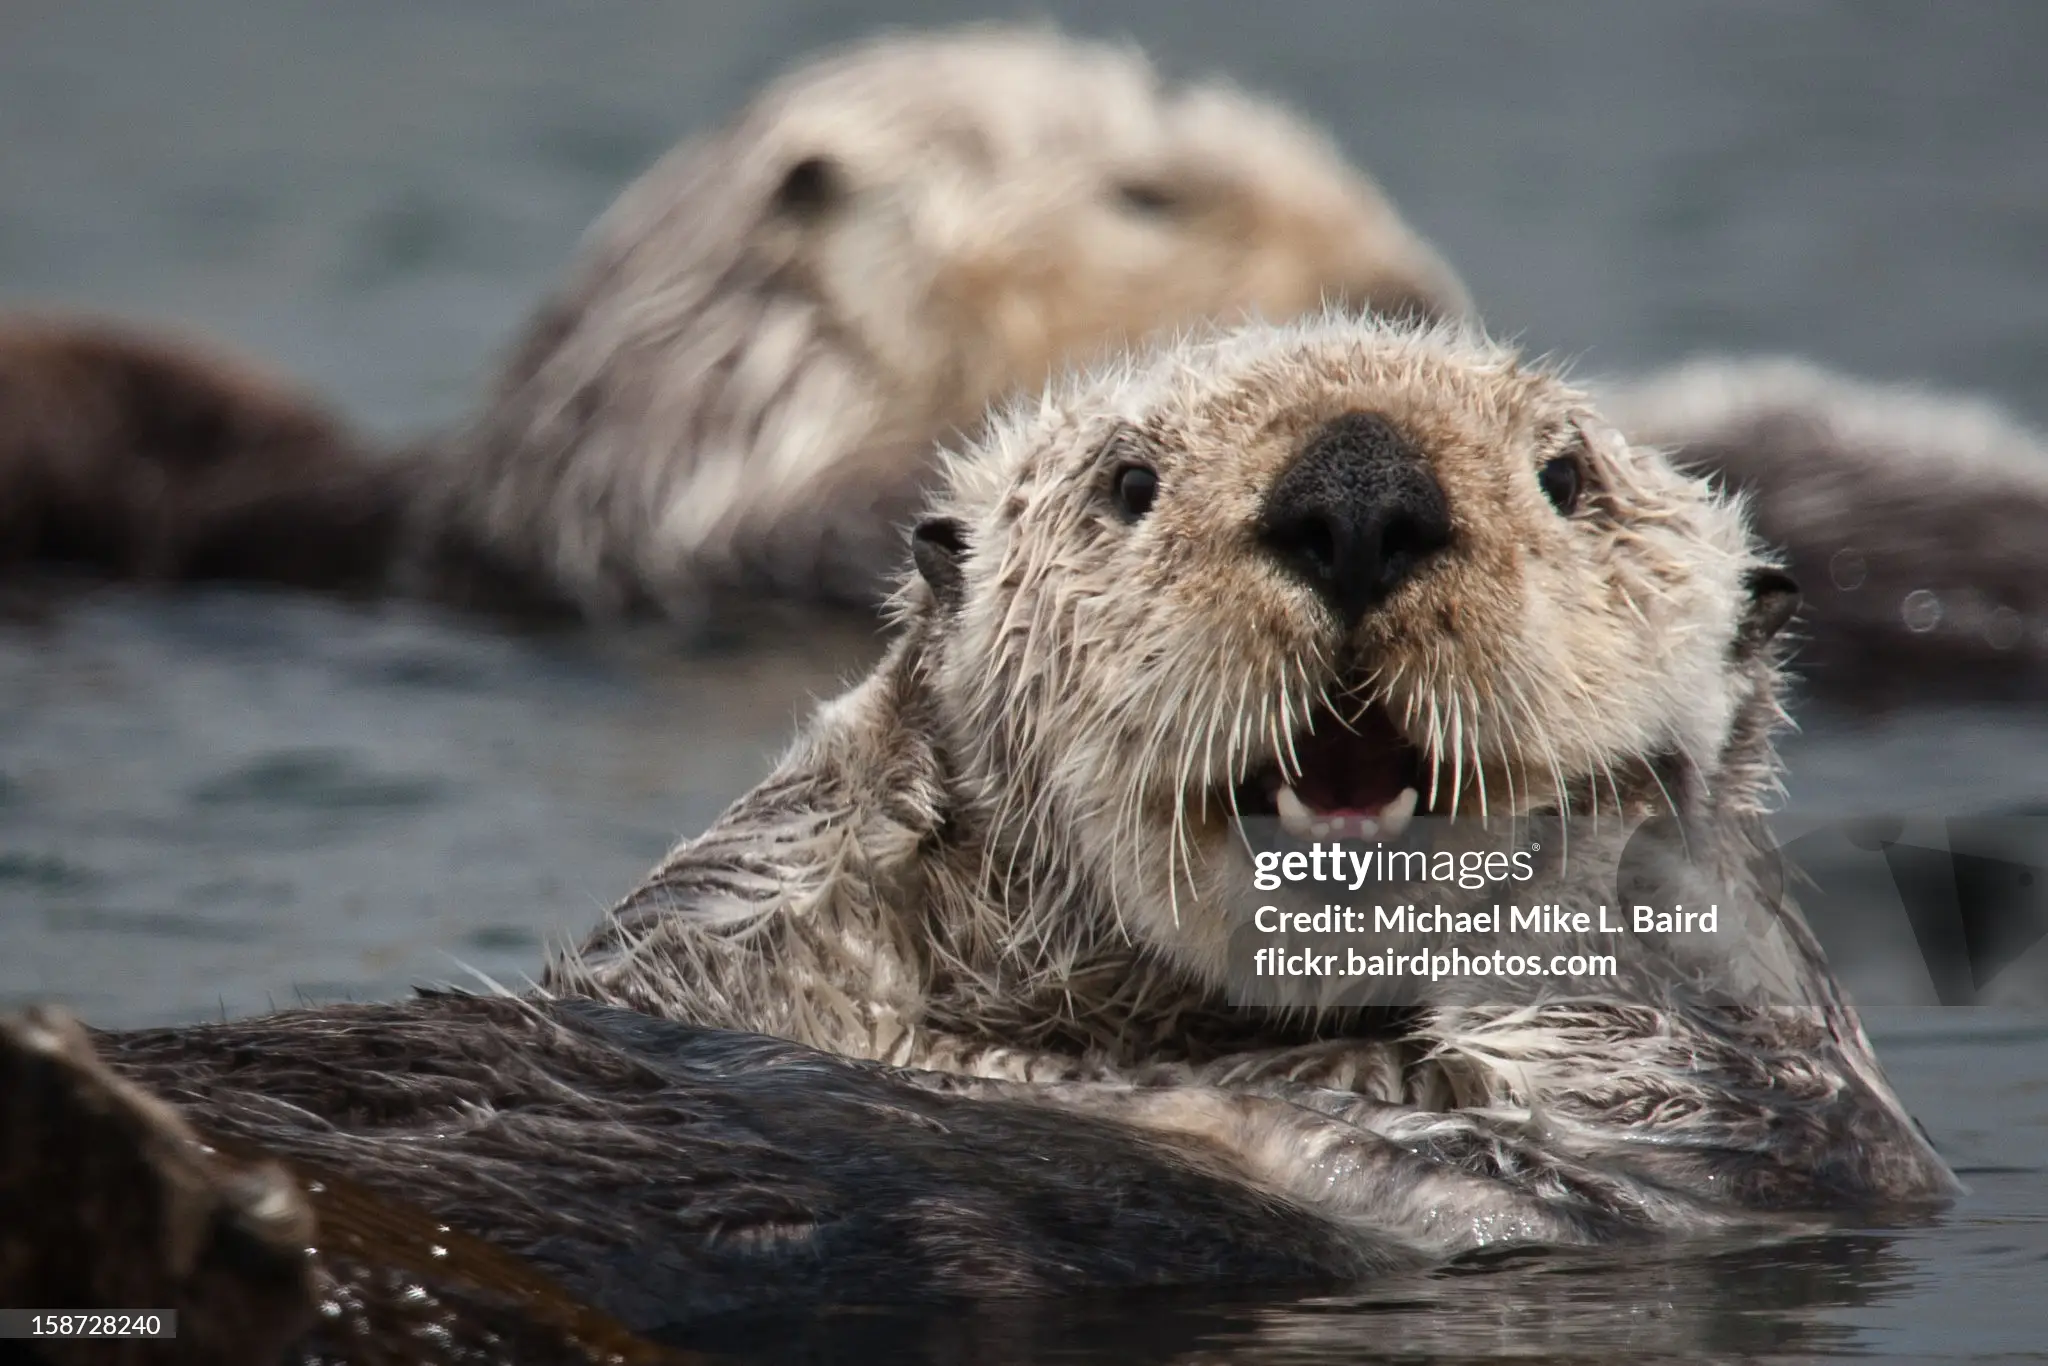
0 315 1956 1359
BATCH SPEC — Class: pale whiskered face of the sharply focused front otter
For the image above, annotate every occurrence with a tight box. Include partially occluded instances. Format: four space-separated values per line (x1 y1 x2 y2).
913 317 1757 978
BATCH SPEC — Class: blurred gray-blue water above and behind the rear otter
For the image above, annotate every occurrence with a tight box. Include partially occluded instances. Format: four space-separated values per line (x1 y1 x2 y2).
16 0 2048 432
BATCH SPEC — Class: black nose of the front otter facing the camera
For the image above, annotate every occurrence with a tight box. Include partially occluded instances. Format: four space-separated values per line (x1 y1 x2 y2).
1260 412 1450 627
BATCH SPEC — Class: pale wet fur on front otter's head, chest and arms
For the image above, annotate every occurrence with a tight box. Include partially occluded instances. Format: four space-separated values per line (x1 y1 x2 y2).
543 317 1954 1227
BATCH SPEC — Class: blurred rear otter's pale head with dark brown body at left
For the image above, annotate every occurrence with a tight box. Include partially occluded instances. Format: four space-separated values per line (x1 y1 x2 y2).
0 29 1466 623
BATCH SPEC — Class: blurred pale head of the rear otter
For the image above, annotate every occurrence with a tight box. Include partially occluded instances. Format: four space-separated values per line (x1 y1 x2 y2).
475 29 1466 614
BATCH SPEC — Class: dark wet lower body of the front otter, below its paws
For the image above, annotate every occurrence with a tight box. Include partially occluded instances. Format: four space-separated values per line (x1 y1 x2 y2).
0 995 1413 1360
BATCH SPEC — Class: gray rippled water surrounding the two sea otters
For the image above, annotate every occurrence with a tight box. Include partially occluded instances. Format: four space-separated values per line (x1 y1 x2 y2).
0 0 2048 1364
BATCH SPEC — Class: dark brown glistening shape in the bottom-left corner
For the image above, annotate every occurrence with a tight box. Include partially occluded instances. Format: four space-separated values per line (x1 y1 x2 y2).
0 1010 688 1366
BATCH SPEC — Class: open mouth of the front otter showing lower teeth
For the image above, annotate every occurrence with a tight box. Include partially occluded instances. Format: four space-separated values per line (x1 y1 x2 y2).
1237 702 1423 840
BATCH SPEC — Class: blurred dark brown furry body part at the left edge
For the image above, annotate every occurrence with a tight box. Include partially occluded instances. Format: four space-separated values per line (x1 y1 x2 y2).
0 322 408 590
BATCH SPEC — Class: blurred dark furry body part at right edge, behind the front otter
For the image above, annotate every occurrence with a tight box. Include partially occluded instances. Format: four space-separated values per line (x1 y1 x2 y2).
1599 356 2048 705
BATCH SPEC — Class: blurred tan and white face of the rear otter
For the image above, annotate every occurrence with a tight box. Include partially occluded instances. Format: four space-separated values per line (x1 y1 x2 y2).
729 31 1466 426
